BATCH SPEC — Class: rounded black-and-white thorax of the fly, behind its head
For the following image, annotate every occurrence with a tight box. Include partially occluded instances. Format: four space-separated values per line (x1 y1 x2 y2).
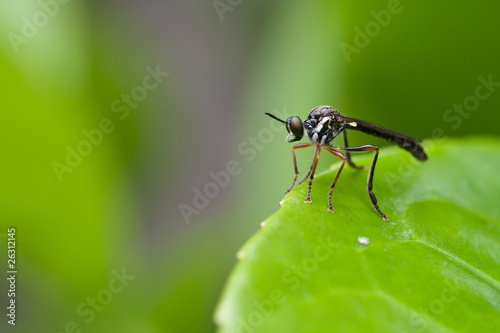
304 105 341 146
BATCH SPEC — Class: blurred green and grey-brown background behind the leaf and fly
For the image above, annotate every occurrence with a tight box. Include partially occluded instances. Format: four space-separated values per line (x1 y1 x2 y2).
0 0 500 333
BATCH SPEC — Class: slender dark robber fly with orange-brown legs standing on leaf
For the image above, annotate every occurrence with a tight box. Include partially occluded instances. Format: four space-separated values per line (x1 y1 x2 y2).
266 105 427 221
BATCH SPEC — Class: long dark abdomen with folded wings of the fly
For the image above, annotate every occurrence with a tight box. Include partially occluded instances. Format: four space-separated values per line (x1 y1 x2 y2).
337 115 427 161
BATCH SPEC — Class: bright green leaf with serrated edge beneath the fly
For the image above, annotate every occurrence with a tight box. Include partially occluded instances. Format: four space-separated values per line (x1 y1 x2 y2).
215 138 500 333
